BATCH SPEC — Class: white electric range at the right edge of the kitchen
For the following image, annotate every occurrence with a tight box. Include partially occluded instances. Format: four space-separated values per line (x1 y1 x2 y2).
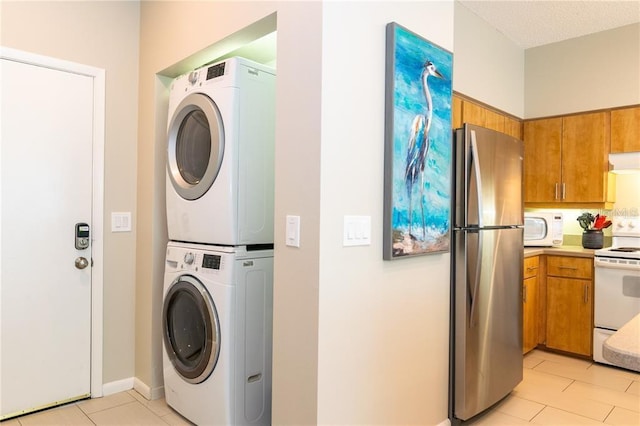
593 216 640 364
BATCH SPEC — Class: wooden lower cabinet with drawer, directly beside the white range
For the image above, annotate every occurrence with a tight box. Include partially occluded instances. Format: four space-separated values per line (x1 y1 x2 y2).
546 256 593 357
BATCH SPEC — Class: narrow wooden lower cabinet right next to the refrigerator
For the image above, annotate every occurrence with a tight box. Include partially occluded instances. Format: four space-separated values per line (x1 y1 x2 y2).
522 256 539 354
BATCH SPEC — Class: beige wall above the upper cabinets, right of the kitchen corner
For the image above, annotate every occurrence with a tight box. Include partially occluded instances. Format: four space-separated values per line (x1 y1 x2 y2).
525 24 640 118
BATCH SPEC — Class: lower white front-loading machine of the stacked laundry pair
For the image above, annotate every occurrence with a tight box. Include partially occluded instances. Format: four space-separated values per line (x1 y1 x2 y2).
162 242 273 425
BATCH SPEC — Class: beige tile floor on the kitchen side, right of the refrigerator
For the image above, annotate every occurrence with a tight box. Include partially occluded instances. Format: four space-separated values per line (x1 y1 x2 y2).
464 350 640 426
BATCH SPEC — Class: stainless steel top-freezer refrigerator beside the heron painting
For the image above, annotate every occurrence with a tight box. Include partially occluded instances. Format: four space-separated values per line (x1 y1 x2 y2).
449 124 524 423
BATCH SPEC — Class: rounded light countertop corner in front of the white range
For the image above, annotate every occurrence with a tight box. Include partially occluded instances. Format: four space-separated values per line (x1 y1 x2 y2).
602 314 640 372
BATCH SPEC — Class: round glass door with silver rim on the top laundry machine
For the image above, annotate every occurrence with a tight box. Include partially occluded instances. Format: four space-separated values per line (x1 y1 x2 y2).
167 93 224 200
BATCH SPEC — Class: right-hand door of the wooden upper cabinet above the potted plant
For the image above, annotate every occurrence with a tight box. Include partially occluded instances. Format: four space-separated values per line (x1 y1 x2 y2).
562 112 610 203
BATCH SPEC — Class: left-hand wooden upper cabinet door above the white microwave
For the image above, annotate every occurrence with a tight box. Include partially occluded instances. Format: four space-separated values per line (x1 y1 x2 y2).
524 118 562 203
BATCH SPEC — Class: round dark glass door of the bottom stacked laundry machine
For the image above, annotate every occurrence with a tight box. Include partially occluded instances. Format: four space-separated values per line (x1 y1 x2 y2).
162 275 220 383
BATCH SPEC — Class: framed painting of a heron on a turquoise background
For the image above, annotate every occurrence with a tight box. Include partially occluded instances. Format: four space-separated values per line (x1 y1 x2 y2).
383 22 453 260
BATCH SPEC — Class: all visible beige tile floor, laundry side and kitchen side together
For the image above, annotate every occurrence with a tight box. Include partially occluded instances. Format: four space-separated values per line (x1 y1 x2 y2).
2 350 640 426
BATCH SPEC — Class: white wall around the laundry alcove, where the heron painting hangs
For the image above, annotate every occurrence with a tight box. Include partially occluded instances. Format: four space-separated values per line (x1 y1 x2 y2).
136 2 453 424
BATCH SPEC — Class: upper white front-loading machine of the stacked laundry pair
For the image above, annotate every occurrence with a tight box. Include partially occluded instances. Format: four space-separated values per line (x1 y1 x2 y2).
167 57 275 245
